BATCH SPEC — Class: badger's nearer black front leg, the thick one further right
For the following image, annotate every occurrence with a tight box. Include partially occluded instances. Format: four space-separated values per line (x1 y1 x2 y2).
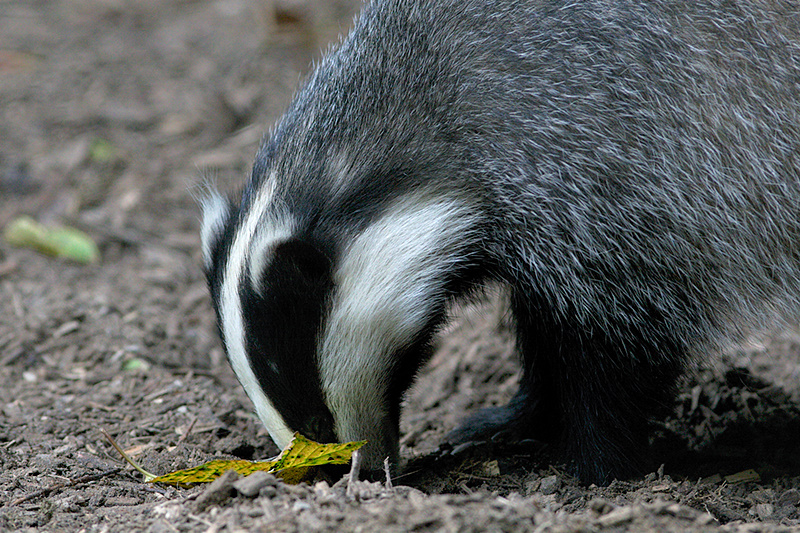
555 323 684 484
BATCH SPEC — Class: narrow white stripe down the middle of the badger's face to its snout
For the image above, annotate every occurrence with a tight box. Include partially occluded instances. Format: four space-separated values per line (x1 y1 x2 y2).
219 178 293 449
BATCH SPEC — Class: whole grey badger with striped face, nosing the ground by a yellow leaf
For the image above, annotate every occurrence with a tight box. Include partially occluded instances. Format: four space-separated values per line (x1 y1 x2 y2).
201 0 800 483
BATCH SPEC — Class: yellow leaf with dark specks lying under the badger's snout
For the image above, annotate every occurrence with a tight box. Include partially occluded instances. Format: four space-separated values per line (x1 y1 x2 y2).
150 433 367 486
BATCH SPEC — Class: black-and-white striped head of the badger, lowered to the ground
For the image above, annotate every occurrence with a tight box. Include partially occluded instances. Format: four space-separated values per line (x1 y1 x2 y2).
201 180 482 470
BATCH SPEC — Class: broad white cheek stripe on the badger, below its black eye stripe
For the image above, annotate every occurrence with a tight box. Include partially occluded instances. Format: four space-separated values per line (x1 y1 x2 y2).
319 192 478 441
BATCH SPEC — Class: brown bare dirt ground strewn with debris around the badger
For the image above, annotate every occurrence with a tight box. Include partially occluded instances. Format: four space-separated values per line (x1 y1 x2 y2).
0 0 800 532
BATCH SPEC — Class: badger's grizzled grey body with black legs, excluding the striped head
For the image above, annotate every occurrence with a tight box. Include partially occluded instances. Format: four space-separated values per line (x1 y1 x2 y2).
205 0 800 481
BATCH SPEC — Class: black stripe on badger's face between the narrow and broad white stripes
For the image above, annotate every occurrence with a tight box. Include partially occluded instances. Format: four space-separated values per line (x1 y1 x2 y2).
239 239 336 442
